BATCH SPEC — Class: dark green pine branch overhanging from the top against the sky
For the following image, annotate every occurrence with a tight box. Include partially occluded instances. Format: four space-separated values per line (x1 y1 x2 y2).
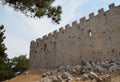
1 0 62 24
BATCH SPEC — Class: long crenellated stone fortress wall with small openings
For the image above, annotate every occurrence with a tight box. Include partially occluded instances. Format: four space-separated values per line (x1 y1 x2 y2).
30 4 120 68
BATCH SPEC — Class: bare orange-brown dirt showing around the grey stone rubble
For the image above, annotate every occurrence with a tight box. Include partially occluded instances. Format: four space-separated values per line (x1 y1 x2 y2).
4 69 120 82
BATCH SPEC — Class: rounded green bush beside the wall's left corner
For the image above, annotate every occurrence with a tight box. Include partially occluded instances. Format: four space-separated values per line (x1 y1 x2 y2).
11 55 29 73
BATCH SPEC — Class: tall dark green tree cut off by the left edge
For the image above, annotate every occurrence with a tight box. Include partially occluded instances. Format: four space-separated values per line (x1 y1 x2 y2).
0 25 14 81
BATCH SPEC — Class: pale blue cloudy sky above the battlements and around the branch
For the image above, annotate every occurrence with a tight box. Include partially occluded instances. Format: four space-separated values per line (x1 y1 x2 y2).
0 0 120 58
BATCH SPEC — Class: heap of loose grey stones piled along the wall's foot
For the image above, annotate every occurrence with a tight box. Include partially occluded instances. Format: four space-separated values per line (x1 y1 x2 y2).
41 59 120 82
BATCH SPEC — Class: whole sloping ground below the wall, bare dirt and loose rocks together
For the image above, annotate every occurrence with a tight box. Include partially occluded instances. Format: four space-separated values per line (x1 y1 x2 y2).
5 59 120 82
